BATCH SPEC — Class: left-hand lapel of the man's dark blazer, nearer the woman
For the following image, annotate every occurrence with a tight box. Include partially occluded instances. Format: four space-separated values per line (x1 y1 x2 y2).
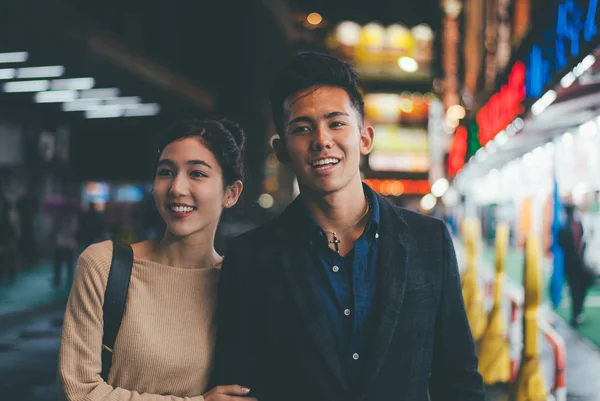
280 200 349 391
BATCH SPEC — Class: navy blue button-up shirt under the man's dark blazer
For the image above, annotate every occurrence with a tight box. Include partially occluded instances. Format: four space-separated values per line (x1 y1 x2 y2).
300 184 379 384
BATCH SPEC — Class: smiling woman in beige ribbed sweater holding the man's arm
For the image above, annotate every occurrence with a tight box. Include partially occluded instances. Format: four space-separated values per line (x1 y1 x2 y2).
58 119 250 401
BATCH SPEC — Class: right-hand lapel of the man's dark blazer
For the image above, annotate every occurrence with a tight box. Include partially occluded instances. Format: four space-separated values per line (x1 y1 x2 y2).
362 198 411 396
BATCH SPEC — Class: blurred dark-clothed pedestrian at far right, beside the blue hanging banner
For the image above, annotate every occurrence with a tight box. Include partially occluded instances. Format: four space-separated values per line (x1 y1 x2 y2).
559 204 594 327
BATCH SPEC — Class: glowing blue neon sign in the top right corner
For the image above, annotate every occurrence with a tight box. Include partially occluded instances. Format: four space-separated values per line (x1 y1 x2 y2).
526 0 598 99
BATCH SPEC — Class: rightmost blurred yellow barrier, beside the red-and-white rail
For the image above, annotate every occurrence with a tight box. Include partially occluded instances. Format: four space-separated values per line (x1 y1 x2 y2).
516 235 546 401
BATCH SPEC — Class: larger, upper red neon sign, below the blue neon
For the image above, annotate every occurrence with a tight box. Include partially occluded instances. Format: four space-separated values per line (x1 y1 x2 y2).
476 61 525 146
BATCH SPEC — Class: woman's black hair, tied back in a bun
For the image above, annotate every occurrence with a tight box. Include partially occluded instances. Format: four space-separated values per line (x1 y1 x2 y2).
157 118 246 185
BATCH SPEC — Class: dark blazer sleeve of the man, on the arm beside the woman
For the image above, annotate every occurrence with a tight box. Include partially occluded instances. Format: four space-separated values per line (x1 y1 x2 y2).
210 241 254 391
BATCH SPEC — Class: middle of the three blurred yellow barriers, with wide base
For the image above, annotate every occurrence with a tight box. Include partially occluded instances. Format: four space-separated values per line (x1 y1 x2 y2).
477 223 511 385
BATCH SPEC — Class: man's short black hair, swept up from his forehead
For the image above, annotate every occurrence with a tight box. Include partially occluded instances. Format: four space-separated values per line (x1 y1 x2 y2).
271 52 365 134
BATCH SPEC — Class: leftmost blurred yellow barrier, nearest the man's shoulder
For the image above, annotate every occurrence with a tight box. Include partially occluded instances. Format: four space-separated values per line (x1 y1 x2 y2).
462 220 487 341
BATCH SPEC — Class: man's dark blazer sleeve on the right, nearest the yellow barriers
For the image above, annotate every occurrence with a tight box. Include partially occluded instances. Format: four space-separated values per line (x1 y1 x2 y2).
429 222 485 401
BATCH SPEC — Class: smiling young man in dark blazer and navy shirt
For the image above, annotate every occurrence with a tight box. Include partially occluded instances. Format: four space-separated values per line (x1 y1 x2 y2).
214 54 484 401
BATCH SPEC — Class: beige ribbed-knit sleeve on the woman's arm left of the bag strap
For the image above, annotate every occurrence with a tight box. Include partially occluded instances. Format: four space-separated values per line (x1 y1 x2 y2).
57 242 203 401
